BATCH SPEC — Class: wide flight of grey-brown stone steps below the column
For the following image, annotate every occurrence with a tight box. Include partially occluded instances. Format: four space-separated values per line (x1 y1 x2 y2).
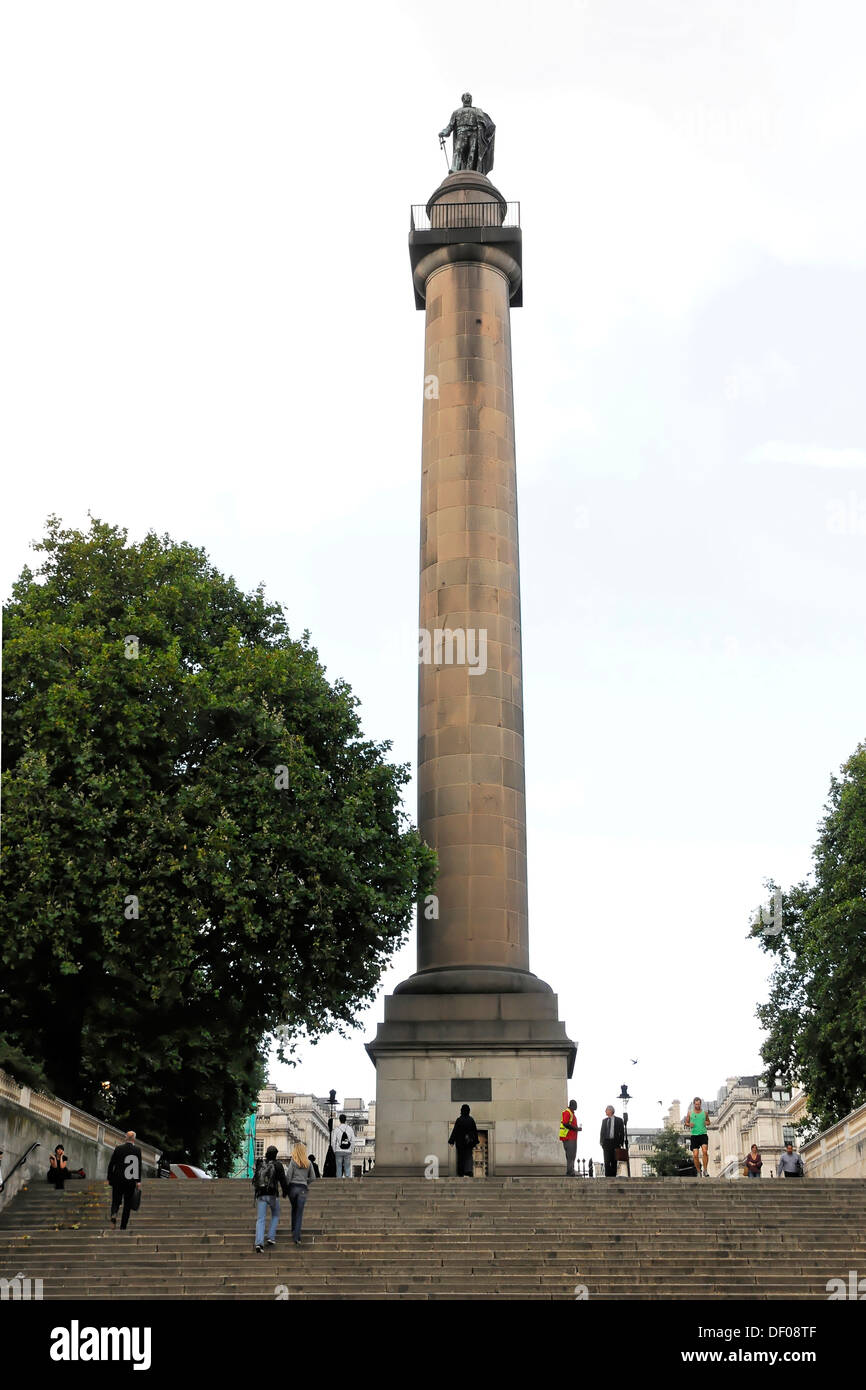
0 1177 866 1300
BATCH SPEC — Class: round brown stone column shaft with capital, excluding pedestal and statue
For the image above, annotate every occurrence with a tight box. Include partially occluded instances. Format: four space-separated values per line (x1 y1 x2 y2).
398 171 546 992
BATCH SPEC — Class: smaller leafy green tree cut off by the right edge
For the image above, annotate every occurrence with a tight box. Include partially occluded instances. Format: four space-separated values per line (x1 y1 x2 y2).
751 744 866 1129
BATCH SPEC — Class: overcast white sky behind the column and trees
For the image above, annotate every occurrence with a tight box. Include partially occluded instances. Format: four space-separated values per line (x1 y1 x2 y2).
0 0 866 1156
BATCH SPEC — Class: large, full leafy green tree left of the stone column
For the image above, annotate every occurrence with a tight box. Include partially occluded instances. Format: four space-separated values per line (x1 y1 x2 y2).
0 517 435 1173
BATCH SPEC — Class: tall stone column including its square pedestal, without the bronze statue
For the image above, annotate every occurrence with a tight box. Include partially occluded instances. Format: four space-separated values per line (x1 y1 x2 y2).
367 171 575 1177
